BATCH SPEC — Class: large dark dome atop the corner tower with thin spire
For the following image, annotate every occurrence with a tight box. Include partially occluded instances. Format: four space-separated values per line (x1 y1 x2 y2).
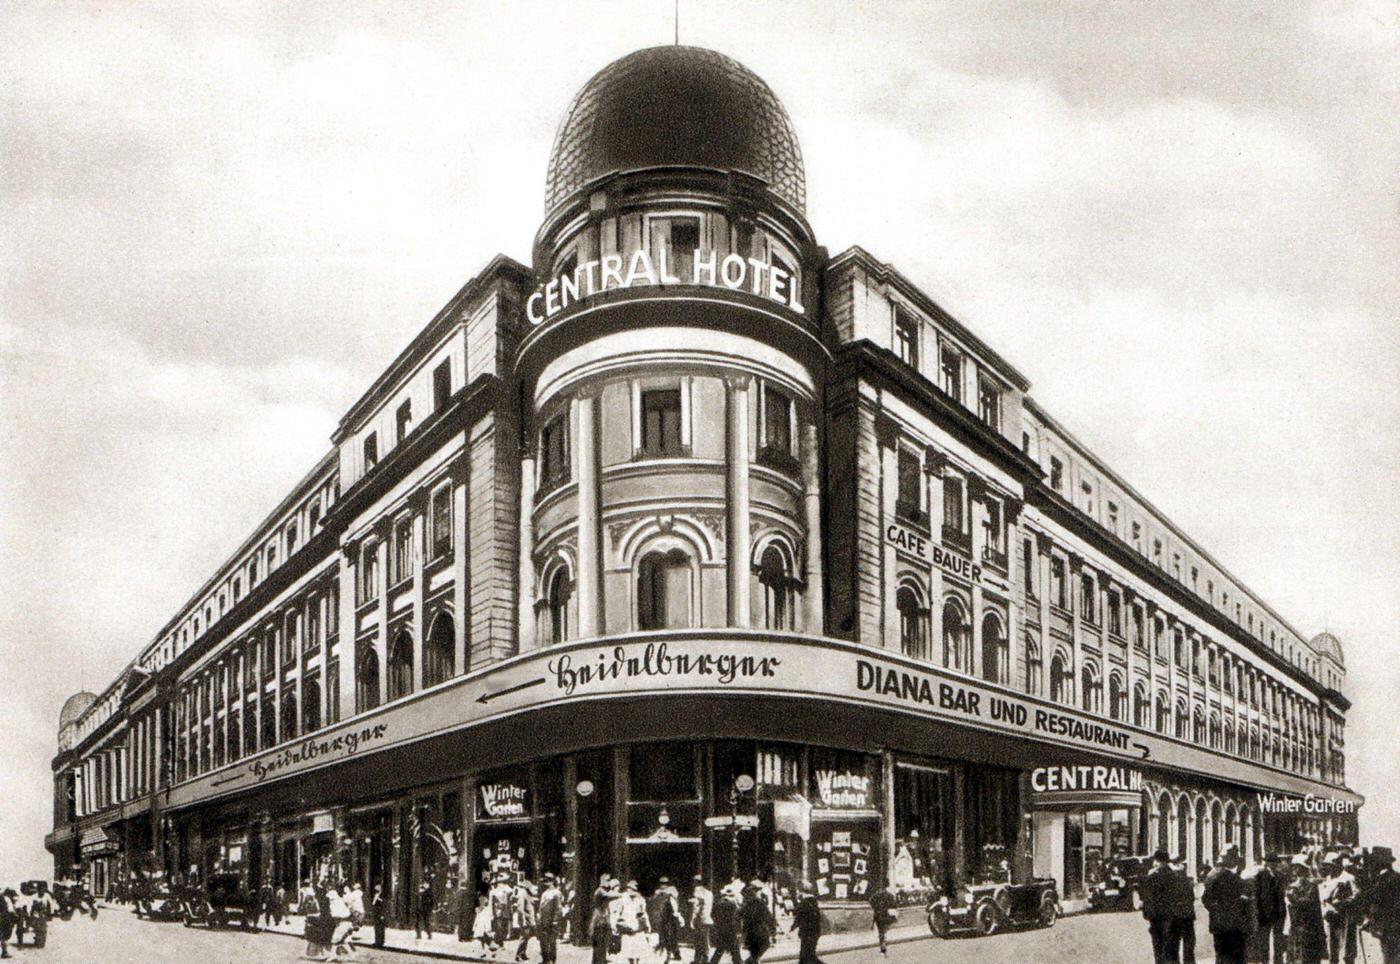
545 46 806 213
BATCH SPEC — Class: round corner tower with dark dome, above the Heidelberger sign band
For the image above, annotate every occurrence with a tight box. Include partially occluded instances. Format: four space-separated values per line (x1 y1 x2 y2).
517 46 827 648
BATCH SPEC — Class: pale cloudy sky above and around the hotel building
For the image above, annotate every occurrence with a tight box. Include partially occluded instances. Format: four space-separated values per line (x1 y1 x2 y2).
0 0 1400 880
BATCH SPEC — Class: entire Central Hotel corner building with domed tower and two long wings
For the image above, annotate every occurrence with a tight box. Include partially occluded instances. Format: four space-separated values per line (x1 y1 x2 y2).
46 45 1361 940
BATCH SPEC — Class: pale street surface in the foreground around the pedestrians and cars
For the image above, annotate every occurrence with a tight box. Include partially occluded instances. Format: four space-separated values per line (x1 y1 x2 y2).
11 908 1380 964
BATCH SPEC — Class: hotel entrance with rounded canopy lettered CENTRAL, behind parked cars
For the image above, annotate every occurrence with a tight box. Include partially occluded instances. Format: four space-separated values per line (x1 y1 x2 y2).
1030 764 1144 901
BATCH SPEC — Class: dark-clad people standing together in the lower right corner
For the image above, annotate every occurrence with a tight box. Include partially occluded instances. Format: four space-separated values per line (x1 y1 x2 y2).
1138 846 1400 964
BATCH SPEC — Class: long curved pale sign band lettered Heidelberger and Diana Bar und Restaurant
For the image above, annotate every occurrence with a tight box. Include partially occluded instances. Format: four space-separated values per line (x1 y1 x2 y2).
168 630 1355 810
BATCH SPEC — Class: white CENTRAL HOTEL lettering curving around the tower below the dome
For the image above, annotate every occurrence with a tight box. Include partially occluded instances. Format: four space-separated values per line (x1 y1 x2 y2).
525 248 806 325
